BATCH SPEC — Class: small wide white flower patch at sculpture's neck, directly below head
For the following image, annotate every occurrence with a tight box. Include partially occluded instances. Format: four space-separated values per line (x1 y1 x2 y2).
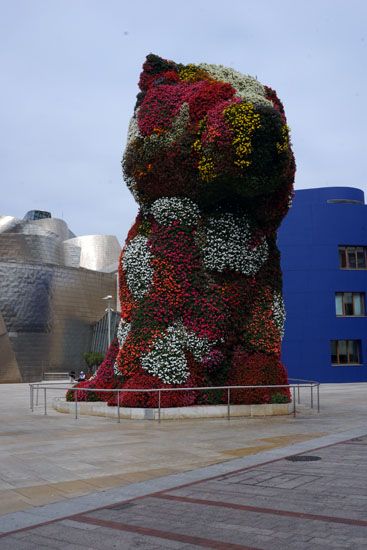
150 197 200 225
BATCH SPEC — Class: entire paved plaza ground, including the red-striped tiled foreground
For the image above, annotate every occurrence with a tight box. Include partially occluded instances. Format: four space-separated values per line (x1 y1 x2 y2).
0 384 367 550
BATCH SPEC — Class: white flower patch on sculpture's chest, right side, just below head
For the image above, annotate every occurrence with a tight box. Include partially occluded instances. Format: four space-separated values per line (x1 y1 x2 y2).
202 213 269 275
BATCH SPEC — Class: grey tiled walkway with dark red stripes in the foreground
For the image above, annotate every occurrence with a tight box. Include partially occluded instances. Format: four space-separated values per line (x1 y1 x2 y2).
0 438 367 550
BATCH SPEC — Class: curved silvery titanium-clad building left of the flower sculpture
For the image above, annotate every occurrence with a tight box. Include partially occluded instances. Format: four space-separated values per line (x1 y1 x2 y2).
0 211 120 382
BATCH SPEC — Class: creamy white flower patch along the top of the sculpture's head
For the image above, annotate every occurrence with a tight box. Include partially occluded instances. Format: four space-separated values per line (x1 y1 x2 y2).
199 63 273 107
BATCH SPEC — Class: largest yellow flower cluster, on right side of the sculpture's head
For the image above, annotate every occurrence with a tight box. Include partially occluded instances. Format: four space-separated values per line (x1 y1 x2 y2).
224 103 261 168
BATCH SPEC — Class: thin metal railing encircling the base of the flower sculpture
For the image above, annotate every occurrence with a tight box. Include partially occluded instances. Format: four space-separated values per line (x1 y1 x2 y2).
29 378 320 423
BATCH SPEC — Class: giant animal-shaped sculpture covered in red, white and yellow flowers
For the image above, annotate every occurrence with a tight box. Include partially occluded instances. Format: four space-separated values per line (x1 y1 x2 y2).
75 55 295 406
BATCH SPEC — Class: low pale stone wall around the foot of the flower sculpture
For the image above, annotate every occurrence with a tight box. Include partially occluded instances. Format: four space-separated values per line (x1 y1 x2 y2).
52 397 293 420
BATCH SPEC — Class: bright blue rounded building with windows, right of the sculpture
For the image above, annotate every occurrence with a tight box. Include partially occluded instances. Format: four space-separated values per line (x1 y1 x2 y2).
278 187 367 382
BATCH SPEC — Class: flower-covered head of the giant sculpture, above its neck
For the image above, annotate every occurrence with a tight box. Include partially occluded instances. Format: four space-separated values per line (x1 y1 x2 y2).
123 55 295 221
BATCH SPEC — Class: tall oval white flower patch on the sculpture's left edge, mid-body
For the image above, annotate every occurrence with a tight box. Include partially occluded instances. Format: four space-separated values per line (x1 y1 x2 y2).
122 235 153 299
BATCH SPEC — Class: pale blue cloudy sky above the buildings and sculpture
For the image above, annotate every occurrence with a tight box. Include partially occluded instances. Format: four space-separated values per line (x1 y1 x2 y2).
0 0 367 243
